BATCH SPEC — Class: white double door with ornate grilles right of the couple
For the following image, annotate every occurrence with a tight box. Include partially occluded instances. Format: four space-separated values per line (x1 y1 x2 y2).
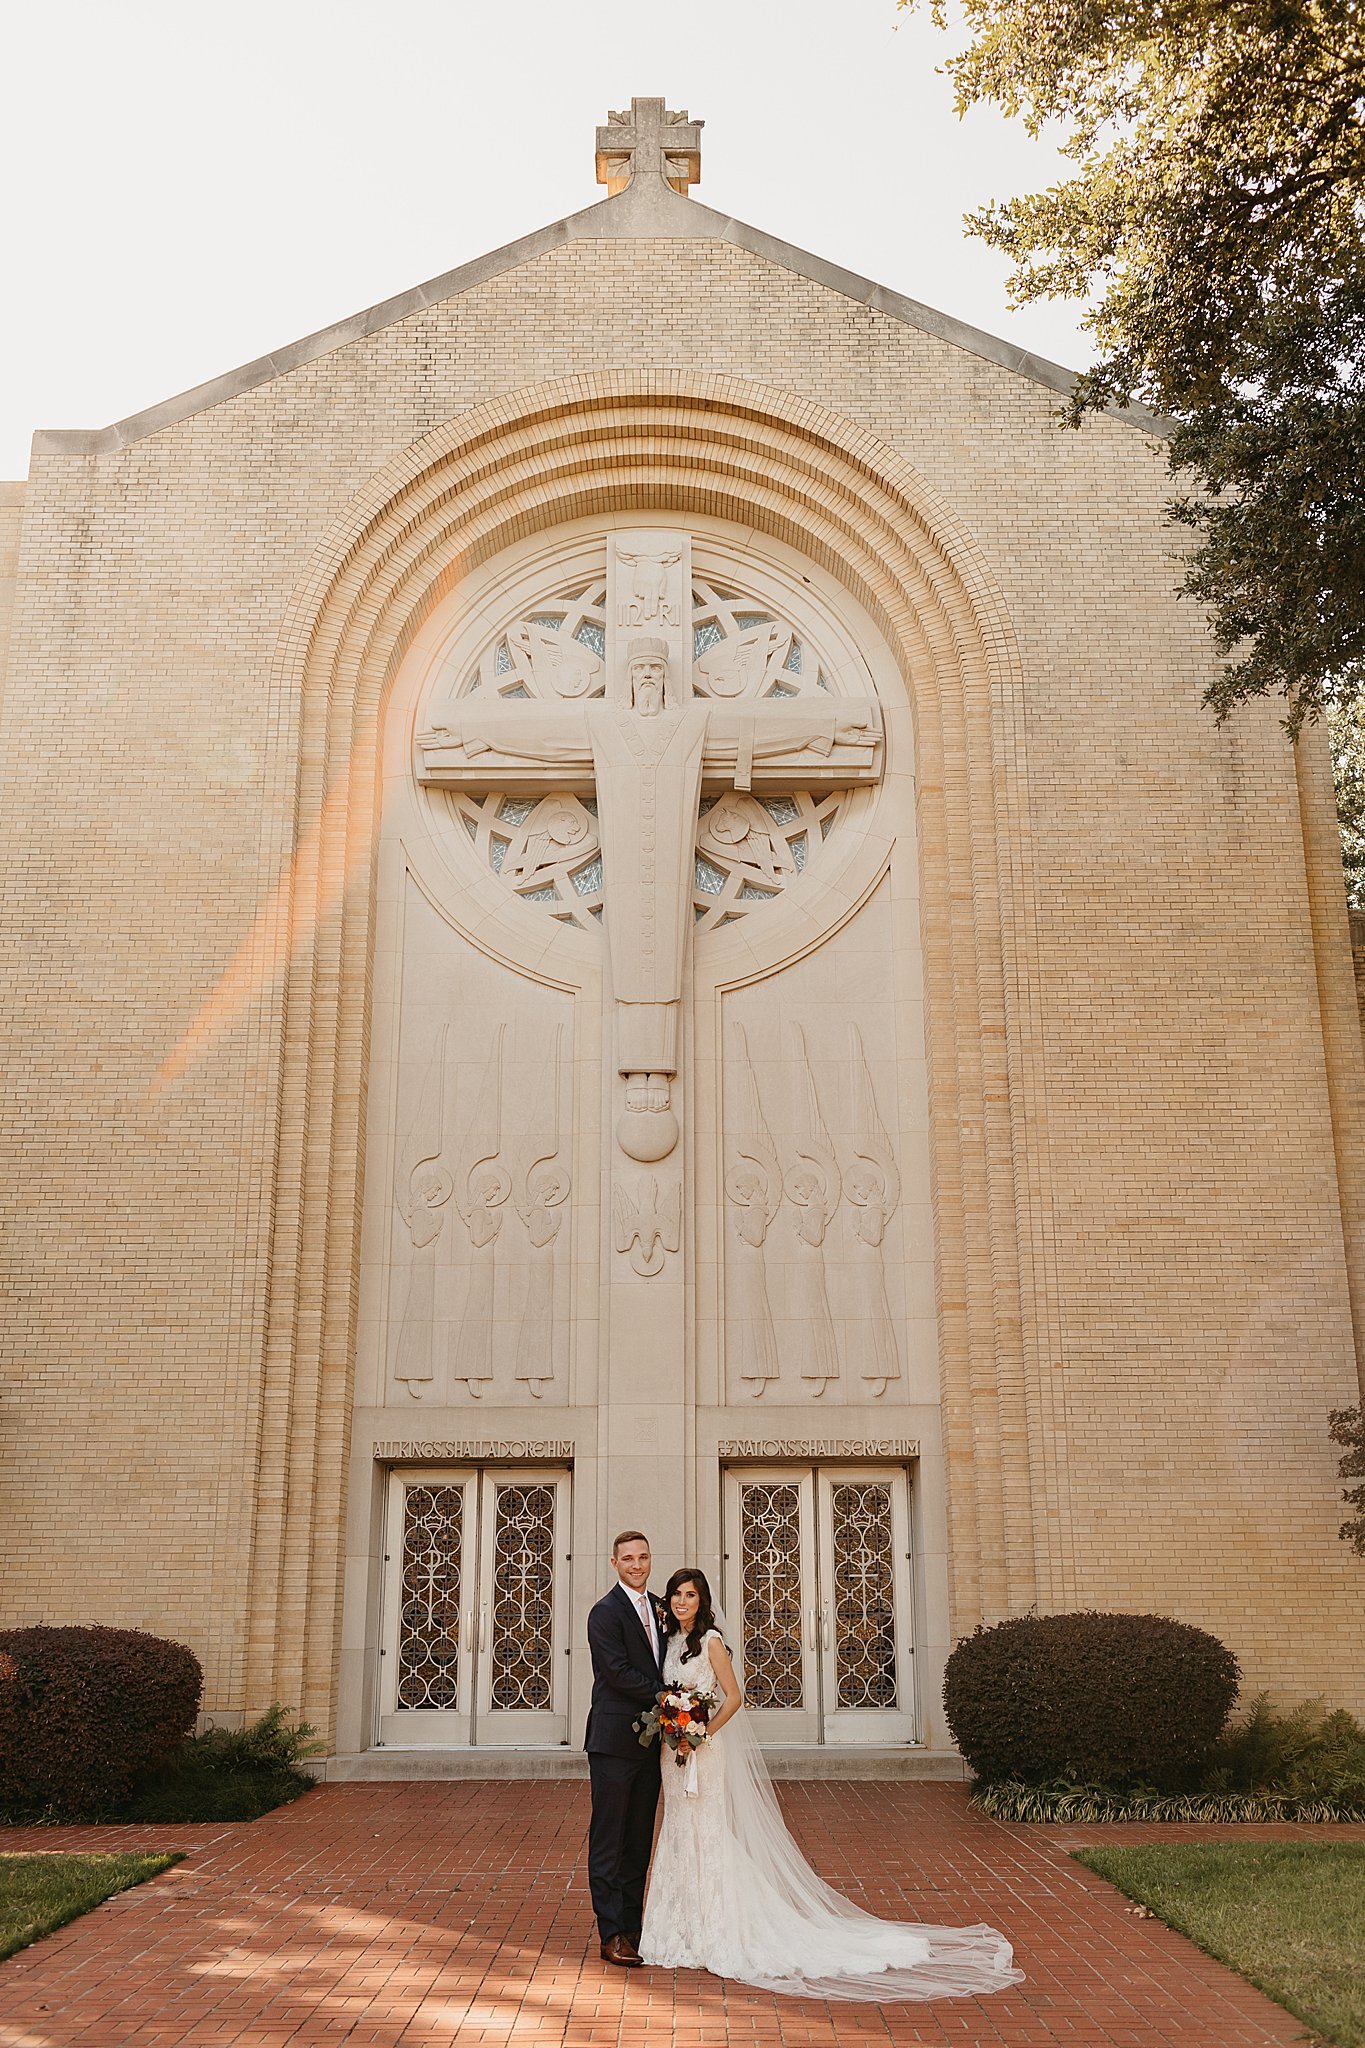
724 1464 915 1743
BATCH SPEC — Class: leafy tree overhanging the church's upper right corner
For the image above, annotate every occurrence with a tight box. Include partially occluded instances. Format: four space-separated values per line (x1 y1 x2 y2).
900 0 1365 735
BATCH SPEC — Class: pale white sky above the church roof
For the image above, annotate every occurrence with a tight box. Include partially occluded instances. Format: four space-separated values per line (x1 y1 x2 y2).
0 0 1091 477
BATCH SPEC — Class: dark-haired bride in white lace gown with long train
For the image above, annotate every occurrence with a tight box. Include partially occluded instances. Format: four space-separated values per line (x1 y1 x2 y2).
641 1567 1021 2003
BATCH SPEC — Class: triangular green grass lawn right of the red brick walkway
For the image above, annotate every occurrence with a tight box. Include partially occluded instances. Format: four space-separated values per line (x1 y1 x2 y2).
1074 1841 1365 2048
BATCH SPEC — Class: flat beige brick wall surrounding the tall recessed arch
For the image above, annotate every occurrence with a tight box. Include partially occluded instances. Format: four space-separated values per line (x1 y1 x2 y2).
0 224 1365 1710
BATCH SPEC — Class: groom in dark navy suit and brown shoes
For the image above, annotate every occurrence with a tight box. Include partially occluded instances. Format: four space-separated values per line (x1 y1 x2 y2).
583 1530 663 1968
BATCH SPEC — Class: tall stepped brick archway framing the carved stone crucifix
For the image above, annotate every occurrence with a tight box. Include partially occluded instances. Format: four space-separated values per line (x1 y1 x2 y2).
248 373 1068 1726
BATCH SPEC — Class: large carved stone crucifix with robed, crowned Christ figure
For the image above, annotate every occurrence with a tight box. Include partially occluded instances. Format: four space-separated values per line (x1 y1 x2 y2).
415 530 882 1163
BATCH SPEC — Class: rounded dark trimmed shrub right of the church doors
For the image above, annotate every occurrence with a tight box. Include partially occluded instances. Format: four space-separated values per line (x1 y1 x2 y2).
943 1614 1240 1792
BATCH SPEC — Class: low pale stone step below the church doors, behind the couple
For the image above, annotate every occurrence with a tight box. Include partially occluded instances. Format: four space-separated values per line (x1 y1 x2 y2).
317 1745 968 1784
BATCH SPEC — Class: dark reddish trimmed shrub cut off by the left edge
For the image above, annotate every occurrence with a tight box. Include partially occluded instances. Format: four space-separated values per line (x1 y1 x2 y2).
0 1628 203 1817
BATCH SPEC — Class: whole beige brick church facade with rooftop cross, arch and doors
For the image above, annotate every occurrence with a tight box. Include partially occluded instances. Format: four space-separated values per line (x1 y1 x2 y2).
0 100 1365 1774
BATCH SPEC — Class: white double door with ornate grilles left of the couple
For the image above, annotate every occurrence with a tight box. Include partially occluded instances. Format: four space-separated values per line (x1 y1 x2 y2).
379 1466 569 1749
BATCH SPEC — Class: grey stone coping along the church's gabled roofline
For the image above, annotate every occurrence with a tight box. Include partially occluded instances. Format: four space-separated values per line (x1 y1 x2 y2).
33 176 1166 455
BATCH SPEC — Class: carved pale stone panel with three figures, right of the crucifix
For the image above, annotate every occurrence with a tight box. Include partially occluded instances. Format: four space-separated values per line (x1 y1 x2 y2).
720 883 935 1407
